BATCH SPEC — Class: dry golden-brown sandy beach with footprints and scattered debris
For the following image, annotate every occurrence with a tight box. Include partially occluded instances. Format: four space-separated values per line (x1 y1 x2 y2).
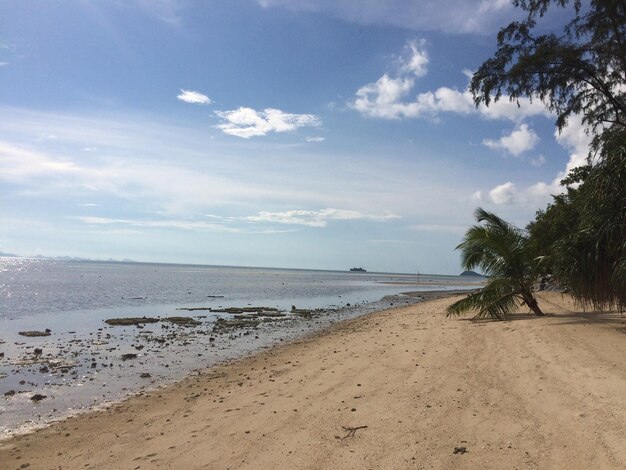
0 293 626 470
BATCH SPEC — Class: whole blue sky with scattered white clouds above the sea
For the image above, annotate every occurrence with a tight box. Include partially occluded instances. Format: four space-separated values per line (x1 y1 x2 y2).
0 0 588 274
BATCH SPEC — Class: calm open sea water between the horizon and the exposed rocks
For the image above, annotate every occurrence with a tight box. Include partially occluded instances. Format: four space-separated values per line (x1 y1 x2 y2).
0 258 467 319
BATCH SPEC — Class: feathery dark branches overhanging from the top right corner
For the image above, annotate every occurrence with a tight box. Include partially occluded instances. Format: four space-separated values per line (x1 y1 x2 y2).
470 0 626 130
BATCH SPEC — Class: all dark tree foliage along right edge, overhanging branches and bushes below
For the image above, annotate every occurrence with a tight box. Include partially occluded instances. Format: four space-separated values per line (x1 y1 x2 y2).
470 0 626 310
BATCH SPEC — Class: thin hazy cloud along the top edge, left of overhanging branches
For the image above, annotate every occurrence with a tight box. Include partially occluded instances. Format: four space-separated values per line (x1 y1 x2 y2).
258 0 515 34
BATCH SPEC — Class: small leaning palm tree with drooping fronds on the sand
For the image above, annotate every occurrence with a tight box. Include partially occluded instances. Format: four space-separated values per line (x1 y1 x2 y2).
447 208 544 318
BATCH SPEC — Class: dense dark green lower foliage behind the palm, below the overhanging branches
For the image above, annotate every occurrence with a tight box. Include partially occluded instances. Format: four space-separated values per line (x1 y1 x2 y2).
528 128 626 310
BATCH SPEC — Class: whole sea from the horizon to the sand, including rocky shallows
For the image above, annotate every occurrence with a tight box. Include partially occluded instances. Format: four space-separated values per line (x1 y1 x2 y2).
0 257 481 439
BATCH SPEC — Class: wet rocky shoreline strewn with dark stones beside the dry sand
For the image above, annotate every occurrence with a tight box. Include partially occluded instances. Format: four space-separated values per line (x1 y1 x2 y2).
0 291 464 441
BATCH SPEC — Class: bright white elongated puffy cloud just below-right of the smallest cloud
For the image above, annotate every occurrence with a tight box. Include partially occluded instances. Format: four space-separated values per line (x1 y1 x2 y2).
215 107 321 139
